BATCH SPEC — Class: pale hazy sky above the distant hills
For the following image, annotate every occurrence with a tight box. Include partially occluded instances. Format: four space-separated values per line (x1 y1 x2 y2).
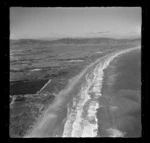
10 7 141 39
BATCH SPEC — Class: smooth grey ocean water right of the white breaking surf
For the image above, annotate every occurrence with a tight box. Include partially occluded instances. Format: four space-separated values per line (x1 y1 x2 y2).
99 49 142 137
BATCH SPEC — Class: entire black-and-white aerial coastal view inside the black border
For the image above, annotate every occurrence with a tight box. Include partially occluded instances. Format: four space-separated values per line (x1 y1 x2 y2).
9 7 142 138
